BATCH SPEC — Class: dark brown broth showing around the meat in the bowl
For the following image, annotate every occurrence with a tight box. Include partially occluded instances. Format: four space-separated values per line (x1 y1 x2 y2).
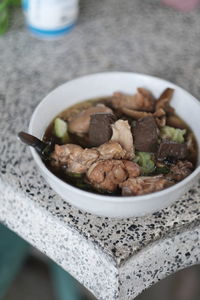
43 97 198 196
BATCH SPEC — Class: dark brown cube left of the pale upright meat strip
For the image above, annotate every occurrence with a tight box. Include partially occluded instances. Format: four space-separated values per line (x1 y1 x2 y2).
89 113 116 147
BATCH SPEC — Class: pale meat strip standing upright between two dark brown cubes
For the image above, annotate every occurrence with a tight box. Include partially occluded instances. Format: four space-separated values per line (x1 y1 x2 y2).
111 120 135 159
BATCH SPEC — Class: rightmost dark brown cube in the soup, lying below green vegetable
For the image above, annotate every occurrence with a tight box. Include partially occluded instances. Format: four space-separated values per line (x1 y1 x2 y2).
157 141 188 160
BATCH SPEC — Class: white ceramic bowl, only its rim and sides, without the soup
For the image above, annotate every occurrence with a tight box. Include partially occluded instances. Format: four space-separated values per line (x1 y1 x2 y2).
29 72 200 217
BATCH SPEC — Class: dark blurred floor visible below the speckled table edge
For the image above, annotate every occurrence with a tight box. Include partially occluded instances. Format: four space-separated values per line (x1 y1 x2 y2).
4 256 200 300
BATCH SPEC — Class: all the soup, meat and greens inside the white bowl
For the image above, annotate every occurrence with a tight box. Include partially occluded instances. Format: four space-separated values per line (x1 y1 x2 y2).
43 88 197 196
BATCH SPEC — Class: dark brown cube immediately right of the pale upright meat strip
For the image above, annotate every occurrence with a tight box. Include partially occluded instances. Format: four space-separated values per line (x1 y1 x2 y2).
132 116 158 152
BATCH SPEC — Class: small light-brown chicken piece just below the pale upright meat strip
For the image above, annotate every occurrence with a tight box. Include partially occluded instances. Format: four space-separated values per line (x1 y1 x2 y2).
96 141 127 160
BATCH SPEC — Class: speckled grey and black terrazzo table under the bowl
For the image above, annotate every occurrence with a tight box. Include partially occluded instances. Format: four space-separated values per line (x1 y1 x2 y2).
0 0 200 300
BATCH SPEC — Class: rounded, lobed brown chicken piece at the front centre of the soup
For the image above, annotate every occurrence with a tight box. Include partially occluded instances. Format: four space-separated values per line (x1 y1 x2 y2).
87 160 140 192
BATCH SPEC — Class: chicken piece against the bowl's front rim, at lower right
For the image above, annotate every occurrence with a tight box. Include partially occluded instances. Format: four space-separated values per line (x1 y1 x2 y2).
119 174 173 196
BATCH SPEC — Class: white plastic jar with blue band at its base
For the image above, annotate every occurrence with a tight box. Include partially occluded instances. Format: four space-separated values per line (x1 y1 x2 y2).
23 0 79 39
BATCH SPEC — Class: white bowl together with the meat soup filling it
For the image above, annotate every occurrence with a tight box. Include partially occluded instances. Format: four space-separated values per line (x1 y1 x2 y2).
29 72 200 217
